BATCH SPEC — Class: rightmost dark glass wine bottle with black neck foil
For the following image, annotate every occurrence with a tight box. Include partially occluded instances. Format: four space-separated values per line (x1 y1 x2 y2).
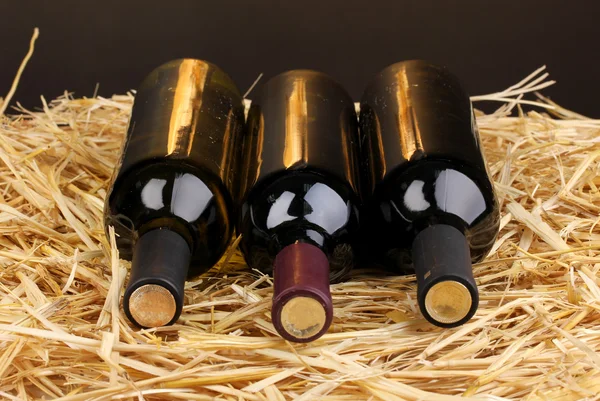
360 61 500 327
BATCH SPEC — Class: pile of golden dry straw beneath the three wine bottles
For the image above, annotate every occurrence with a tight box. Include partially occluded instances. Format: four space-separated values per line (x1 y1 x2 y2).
0 32 600 401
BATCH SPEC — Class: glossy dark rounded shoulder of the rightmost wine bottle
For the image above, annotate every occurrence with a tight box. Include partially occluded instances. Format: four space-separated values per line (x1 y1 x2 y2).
363 159 500 261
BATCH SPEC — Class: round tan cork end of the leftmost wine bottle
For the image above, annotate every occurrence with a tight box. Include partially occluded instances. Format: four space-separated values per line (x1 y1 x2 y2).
128 284 177 327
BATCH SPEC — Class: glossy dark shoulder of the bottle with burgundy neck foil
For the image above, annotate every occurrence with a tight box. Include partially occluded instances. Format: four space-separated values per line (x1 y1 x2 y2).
238 171 359 280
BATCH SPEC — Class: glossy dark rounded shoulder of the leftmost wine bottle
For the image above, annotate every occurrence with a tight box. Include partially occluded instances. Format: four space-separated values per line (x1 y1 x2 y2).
105 161 233 266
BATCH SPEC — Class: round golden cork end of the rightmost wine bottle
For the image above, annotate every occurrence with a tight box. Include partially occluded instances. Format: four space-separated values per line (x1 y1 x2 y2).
425 280 473 324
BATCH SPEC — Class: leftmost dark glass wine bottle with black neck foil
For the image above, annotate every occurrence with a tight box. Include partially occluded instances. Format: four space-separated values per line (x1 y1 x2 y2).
105 59 244 327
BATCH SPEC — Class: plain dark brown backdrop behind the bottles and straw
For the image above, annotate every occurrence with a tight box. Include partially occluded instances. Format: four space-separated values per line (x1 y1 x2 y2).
0 0 600 117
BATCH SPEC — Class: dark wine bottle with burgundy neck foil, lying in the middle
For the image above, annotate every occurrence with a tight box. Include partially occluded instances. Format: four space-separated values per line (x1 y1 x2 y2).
239 70 359 342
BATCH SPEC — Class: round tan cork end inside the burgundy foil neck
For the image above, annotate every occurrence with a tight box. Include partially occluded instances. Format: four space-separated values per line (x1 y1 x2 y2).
279 296 327 340
